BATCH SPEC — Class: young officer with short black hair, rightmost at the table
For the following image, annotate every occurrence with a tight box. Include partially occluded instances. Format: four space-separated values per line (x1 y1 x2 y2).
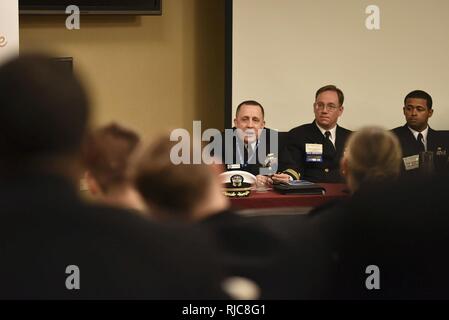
393 90 448 174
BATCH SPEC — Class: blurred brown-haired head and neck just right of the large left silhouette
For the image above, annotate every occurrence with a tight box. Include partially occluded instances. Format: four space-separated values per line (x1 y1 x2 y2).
83 123 147 212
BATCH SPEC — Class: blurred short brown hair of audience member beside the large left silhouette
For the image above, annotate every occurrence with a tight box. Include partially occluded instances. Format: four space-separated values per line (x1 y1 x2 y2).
83 123 140 191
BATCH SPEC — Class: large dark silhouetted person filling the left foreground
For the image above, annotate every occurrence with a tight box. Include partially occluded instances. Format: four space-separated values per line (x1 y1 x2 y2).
0 55 224 299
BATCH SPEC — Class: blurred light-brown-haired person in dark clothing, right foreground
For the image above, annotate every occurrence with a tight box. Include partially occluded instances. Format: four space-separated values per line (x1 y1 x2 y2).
298 128 449 299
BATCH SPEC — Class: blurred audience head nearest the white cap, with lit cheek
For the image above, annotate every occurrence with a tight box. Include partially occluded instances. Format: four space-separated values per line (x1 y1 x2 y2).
136 136 229 220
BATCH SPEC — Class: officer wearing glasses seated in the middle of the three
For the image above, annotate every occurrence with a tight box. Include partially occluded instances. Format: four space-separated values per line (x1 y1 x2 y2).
273 85 351 182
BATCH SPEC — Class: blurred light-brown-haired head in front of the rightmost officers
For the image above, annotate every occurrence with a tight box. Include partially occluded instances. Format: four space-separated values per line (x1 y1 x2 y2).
341 127 402 192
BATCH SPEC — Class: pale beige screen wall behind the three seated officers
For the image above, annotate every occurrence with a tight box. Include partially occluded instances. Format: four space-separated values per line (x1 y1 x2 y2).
233 0 449 130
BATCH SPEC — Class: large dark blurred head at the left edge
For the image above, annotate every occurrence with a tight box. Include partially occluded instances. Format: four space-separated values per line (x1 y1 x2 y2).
0 55 89 177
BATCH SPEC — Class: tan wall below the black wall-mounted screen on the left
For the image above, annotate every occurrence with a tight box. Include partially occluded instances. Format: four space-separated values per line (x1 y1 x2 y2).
20 0 225 141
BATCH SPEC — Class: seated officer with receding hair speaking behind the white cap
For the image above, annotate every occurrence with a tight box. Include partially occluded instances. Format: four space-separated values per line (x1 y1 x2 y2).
217 100 278 185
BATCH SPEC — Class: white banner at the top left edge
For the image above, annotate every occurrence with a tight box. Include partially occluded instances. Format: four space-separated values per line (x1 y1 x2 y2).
0 0 19 64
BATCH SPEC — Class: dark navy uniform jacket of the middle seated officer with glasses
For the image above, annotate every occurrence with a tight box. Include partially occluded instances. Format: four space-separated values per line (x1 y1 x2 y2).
280 122 351 183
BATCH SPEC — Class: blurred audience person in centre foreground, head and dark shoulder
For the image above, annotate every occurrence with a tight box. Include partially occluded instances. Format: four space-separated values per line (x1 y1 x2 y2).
136 136 328 299
